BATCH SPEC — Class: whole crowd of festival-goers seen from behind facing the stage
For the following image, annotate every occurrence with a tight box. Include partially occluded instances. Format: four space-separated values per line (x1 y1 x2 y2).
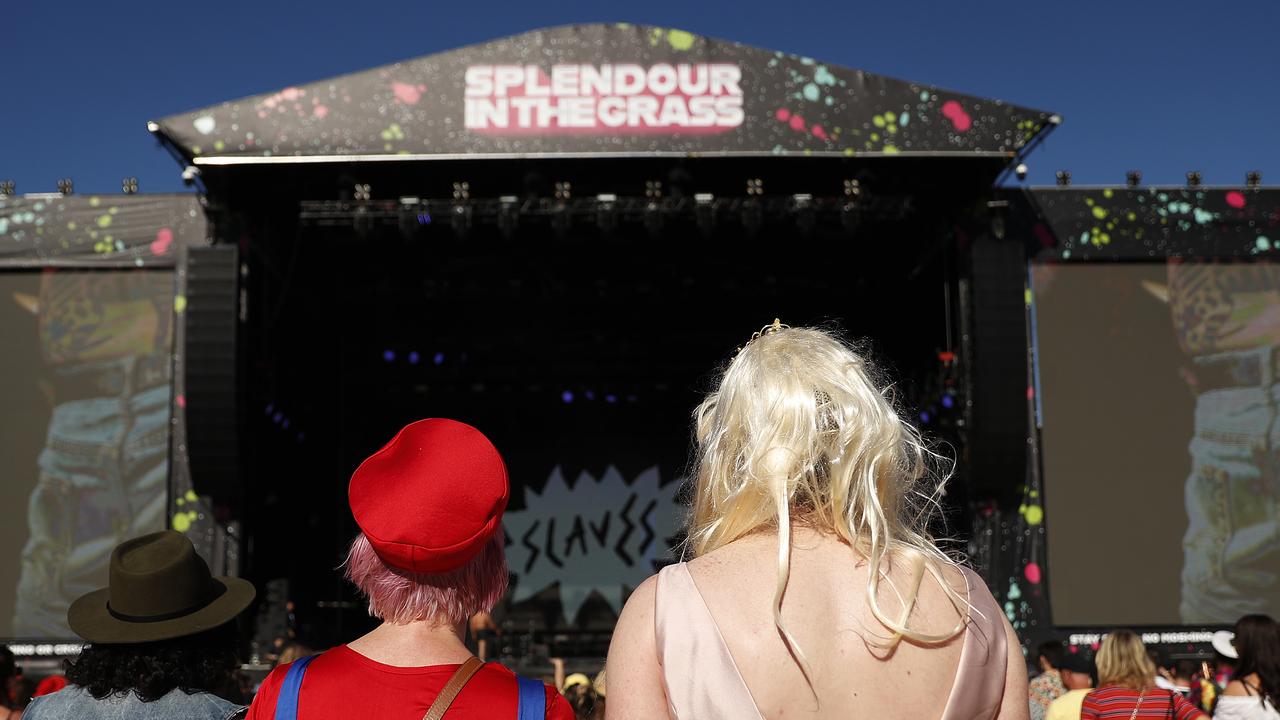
0 322 1280 720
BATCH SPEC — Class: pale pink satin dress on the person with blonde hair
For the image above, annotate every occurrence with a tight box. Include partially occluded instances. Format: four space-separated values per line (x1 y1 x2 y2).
654 562 1009 720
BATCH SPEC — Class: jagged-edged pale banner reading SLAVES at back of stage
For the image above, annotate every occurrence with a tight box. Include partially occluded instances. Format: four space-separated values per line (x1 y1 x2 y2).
503 466 681 621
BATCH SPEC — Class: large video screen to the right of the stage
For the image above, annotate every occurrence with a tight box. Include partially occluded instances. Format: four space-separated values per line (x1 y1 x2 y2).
1032 261 1280 626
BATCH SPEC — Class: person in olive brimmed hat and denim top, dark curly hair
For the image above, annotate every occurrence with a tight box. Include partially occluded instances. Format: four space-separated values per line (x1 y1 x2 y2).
23 530 255 720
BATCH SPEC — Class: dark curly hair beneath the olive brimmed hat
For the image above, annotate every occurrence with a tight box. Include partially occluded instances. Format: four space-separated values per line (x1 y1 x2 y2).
67 623 239 702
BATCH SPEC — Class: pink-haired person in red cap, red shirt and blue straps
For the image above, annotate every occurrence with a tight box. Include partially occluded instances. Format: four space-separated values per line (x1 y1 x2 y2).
248 419 573 720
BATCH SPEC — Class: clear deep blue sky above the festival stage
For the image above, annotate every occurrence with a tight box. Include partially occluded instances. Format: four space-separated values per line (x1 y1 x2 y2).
0 0 1280 192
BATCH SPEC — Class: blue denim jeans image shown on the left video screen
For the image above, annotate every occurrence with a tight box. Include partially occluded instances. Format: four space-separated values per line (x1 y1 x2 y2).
13 357 170 637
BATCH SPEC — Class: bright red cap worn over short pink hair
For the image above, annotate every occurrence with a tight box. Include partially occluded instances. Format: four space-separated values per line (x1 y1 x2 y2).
347 418 509 573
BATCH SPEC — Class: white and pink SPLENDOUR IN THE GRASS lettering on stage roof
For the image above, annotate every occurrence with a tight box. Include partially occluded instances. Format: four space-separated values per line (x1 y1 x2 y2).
465 63 745 135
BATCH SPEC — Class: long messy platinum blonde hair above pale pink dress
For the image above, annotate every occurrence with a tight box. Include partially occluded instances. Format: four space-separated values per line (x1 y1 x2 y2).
687 322 969 683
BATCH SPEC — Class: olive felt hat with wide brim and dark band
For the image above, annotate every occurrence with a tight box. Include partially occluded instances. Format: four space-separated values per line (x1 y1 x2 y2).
67 530 255 644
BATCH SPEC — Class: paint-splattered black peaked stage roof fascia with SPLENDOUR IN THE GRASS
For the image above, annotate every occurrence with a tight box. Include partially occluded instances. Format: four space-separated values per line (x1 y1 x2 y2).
148 23 1059 167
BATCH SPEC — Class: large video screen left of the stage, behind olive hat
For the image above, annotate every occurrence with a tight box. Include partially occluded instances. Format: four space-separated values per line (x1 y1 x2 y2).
0 269 174 639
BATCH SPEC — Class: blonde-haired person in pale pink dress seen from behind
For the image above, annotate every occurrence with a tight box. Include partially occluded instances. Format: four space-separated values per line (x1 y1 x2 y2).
607 322 1028 720
